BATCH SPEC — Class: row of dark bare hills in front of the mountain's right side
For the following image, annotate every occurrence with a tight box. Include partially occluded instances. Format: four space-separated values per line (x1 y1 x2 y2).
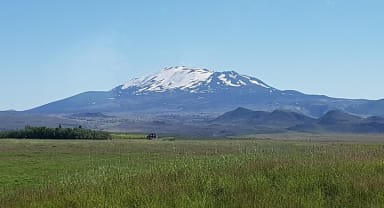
211 108 384 133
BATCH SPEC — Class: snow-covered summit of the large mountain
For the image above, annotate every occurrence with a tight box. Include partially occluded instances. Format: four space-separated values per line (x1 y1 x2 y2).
119 66 273 95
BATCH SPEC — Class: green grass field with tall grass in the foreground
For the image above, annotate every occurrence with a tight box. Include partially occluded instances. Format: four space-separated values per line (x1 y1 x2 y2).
0 139 384 208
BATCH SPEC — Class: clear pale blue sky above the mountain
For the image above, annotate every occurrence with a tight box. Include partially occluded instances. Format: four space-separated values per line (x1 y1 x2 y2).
0 0 384 110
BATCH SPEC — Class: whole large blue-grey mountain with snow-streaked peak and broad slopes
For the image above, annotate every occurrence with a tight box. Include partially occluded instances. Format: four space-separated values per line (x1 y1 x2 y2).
29 66 384 117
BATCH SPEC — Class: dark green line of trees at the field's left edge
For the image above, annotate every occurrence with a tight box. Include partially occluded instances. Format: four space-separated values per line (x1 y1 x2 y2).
0 126 111 139
